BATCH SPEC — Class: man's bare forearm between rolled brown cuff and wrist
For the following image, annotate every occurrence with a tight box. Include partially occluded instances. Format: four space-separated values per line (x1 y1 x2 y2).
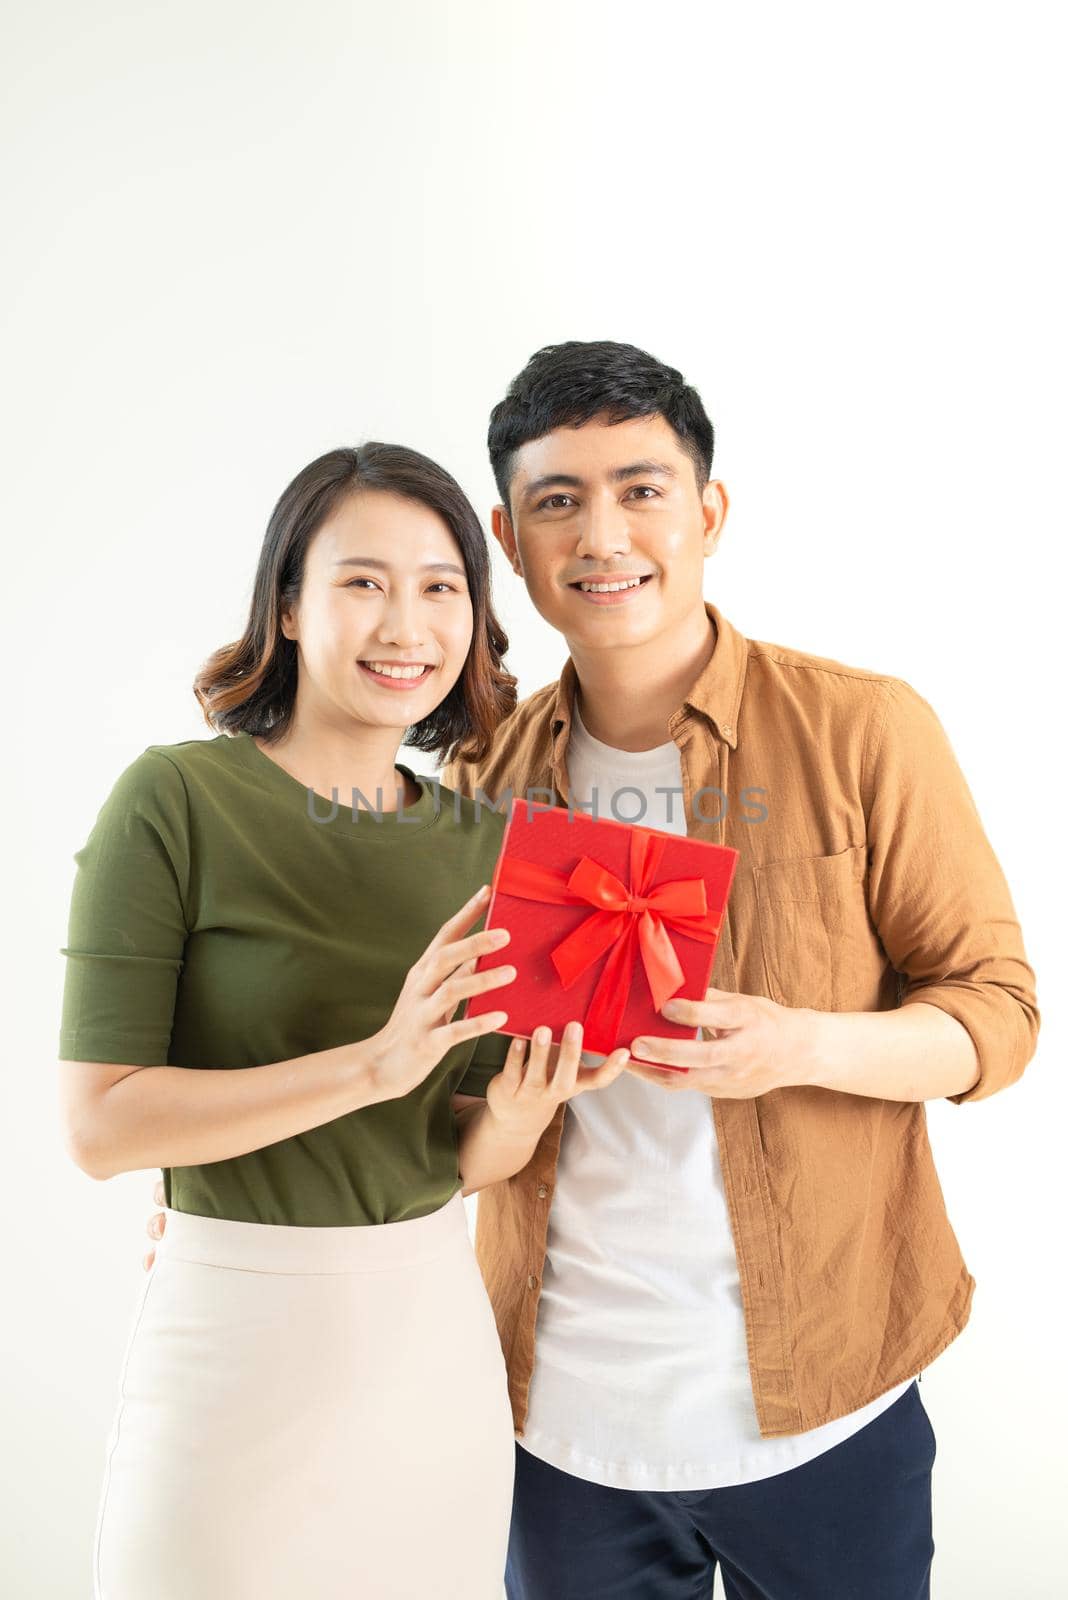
803 1002 978 1101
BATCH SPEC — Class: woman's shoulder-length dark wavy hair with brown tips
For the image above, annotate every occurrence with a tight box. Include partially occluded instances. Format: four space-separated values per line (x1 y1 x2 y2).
193 443 516 762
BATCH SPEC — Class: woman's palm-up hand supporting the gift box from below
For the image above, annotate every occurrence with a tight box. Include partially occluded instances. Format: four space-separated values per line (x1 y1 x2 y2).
486 1022 630 1139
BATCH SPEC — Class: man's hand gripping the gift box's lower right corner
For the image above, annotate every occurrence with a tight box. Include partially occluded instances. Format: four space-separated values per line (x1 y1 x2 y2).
627 989 820 1099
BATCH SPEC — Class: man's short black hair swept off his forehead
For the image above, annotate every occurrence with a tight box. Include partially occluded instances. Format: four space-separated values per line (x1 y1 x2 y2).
486 339 715 506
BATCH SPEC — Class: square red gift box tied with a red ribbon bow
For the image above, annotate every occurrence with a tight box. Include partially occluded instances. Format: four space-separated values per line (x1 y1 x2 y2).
467 798 739 1056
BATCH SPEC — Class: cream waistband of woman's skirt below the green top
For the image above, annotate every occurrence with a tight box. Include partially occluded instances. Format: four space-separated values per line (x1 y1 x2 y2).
157 1189 470 1272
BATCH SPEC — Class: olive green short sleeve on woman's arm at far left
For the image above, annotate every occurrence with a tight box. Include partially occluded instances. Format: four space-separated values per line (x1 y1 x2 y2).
59 747 189 1067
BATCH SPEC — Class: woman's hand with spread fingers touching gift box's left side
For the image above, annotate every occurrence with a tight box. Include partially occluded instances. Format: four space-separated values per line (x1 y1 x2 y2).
366 883 515 1101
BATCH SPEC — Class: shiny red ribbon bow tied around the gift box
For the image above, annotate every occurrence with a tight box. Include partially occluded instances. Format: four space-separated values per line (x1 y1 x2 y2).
497 829 721 1053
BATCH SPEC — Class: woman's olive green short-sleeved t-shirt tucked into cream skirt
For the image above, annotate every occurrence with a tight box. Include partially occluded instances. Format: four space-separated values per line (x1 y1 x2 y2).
59 733 508 1227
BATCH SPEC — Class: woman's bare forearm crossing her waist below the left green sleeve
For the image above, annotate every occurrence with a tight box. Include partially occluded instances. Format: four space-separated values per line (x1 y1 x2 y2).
69 1040 382 1178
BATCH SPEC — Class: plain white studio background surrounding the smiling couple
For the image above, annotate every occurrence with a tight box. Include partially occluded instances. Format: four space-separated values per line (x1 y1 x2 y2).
0 0 1068 1600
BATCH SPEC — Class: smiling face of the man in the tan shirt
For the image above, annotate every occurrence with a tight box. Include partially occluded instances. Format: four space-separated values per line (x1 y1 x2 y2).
494 416 727 650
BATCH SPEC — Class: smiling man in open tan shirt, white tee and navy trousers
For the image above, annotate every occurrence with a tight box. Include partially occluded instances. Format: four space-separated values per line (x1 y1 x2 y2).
443 342 1039 1600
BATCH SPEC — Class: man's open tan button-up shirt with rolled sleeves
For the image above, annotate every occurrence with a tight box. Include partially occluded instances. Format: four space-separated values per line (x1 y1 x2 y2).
441 603 1039 1437
